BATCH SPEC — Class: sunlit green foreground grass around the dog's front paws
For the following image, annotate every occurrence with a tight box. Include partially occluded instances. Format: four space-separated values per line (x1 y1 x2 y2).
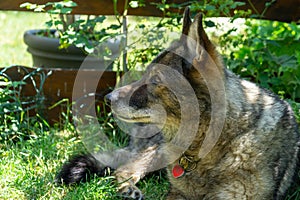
0 130 168 200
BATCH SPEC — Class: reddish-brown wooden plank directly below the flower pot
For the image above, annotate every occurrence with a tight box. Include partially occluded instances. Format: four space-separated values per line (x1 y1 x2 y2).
5 66 116 124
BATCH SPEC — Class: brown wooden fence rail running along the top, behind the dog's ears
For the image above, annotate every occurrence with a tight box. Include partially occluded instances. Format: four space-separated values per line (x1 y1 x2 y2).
0 0 300 22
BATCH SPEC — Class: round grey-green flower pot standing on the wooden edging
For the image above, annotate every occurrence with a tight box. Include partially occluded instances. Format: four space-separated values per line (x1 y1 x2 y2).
24 29 120 70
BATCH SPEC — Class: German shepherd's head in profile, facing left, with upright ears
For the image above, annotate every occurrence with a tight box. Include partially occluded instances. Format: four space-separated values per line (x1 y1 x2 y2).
106 8 222 141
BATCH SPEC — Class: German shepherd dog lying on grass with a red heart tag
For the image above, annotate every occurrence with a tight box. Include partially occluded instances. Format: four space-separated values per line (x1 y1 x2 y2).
57 8 300 200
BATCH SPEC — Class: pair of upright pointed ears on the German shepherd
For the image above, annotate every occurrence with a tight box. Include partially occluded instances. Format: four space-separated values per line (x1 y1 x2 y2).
180 8 224 80
